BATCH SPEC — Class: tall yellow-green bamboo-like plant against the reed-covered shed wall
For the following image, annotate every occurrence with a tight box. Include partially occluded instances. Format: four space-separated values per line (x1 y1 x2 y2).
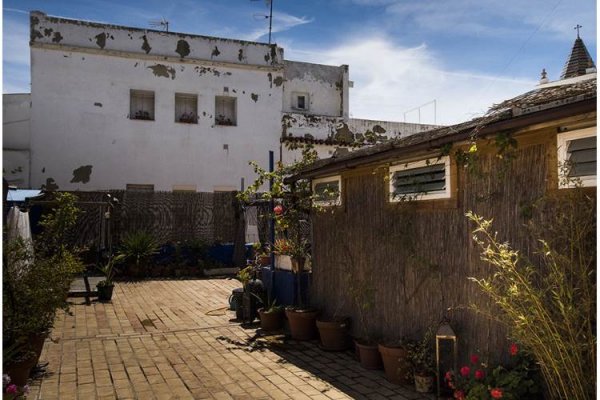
467 194 596 400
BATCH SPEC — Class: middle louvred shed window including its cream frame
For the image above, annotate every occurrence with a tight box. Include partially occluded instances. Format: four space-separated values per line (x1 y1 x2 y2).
389 156 450 202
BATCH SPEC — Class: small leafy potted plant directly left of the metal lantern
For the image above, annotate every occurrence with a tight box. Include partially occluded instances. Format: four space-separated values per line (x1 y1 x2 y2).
408 327 436 393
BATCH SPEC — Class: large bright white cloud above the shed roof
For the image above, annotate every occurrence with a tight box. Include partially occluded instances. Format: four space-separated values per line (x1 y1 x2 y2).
286 37 536 124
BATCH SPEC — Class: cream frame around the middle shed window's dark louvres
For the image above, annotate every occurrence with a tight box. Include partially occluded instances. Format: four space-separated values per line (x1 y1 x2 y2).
388 156 452 203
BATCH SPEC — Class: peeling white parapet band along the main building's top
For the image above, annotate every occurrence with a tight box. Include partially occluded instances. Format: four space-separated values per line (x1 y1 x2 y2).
30 11 283 68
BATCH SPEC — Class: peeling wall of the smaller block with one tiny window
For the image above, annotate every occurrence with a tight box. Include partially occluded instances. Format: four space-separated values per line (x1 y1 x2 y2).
284 61 348 117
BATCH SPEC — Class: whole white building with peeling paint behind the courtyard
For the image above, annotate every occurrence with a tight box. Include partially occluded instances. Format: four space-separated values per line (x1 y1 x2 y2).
19 11 436 191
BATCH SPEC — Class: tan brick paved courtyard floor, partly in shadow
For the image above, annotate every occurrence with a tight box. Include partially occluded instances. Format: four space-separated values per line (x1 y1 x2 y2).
29 279 433 400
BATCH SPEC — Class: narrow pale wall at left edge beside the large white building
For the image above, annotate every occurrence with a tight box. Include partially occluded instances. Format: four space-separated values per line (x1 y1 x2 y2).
2 93 31 188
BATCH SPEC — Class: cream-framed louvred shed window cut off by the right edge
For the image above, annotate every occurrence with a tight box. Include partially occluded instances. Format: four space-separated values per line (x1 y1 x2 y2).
557 128 597 188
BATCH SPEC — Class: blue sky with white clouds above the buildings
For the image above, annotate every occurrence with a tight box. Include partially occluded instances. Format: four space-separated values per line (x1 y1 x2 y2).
3 0 597 124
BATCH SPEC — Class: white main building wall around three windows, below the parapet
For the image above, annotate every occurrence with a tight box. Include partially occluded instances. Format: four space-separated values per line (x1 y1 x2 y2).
31 47 282 191
